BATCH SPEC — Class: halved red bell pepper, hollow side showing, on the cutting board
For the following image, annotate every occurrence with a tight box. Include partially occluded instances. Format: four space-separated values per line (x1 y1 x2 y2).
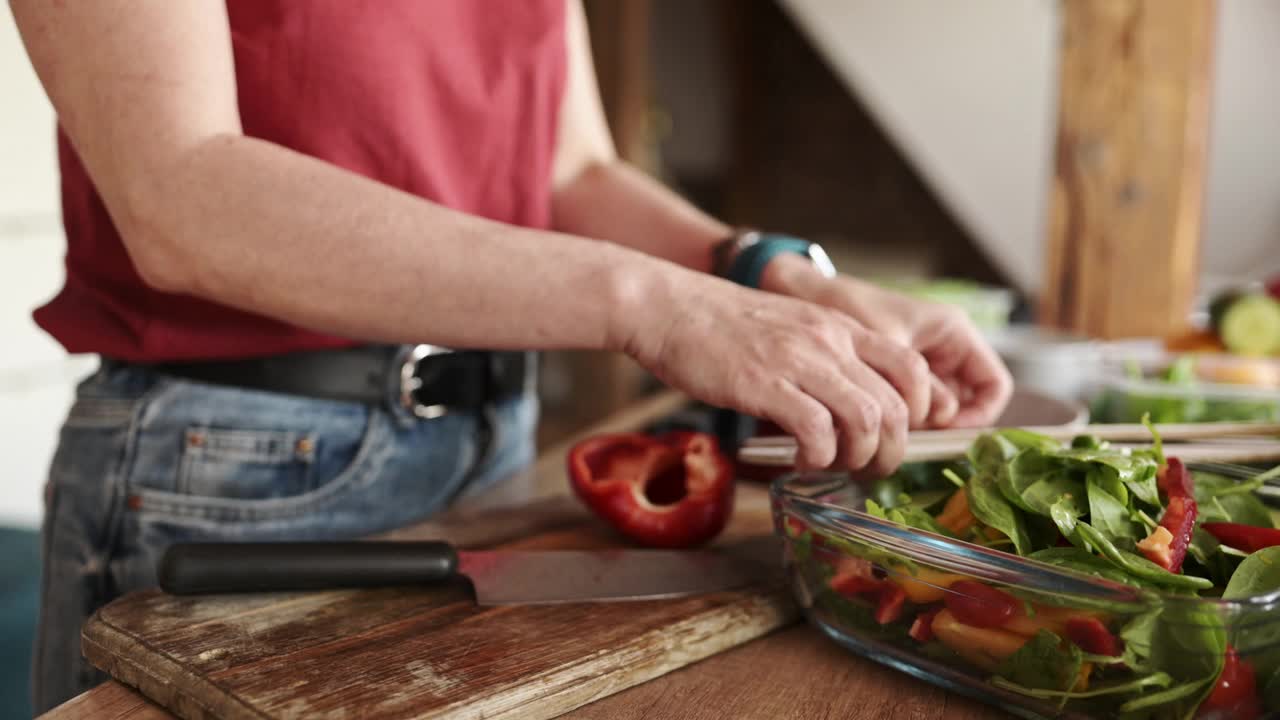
568 432 733 547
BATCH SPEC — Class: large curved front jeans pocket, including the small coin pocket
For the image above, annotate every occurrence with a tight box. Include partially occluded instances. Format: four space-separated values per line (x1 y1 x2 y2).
127 382 389 523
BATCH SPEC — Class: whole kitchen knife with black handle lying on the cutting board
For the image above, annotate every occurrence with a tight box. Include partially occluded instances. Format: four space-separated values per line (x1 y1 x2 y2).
157 537 782 605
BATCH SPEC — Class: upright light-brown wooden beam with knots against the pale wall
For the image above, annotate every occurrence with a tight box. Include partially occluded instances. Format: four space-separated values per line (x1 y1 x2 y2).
1041 0 1216 338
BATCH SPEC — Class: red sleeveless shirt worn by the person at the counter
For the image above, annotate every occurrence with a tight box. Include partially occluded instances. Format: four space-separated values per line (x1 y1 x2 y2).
35 0 566 361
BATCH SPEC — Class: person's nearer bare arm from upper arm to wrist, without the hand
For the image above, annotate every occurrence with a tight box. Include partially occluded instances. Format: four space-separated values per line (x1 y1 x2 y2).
13 0 681 348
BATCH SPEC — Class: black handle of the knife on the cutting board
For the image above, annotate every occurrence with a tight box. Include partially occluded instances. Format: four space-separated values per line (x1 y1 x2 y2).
157 541 458 594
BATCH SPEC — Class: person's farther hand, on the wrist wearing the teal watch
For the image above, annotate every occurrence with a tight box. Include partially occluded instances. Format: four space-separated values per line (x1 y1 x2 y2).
760 255 1014 428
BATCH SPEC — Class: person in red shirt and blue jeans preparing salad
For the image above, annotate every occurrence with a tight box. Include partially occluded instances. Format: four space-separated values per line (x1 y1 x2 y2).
10 0 1011 711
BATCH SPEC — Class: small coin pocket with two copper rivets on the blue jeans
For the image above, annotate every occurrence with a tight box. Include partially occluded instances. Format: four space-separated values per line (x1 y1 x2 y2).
177 427 316 500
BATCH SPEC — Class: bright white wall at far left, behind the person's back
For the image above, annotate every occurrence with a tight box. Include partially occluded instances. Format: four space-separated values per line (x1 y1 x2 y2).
0 13 92 527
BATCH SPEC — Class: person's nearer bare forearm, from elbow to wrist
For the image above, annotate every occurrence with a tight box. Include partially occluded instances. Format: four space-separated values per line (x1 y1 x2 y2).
128 136 684 348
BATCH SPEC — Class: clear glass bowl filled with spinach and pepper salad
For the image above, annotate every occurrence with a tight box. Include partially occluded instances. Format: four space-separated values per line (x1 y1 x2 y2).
771 465 1280 720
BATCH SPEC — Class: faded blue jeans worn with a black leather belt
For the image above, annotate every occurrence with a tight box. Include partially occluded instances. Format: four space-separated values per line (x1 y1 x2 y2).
33 356 538 714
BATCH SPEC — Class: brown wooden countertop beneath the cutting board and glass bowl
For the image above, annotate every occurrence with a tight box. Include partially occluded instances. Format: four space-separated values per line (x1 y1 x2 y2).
44 393 1005 720
